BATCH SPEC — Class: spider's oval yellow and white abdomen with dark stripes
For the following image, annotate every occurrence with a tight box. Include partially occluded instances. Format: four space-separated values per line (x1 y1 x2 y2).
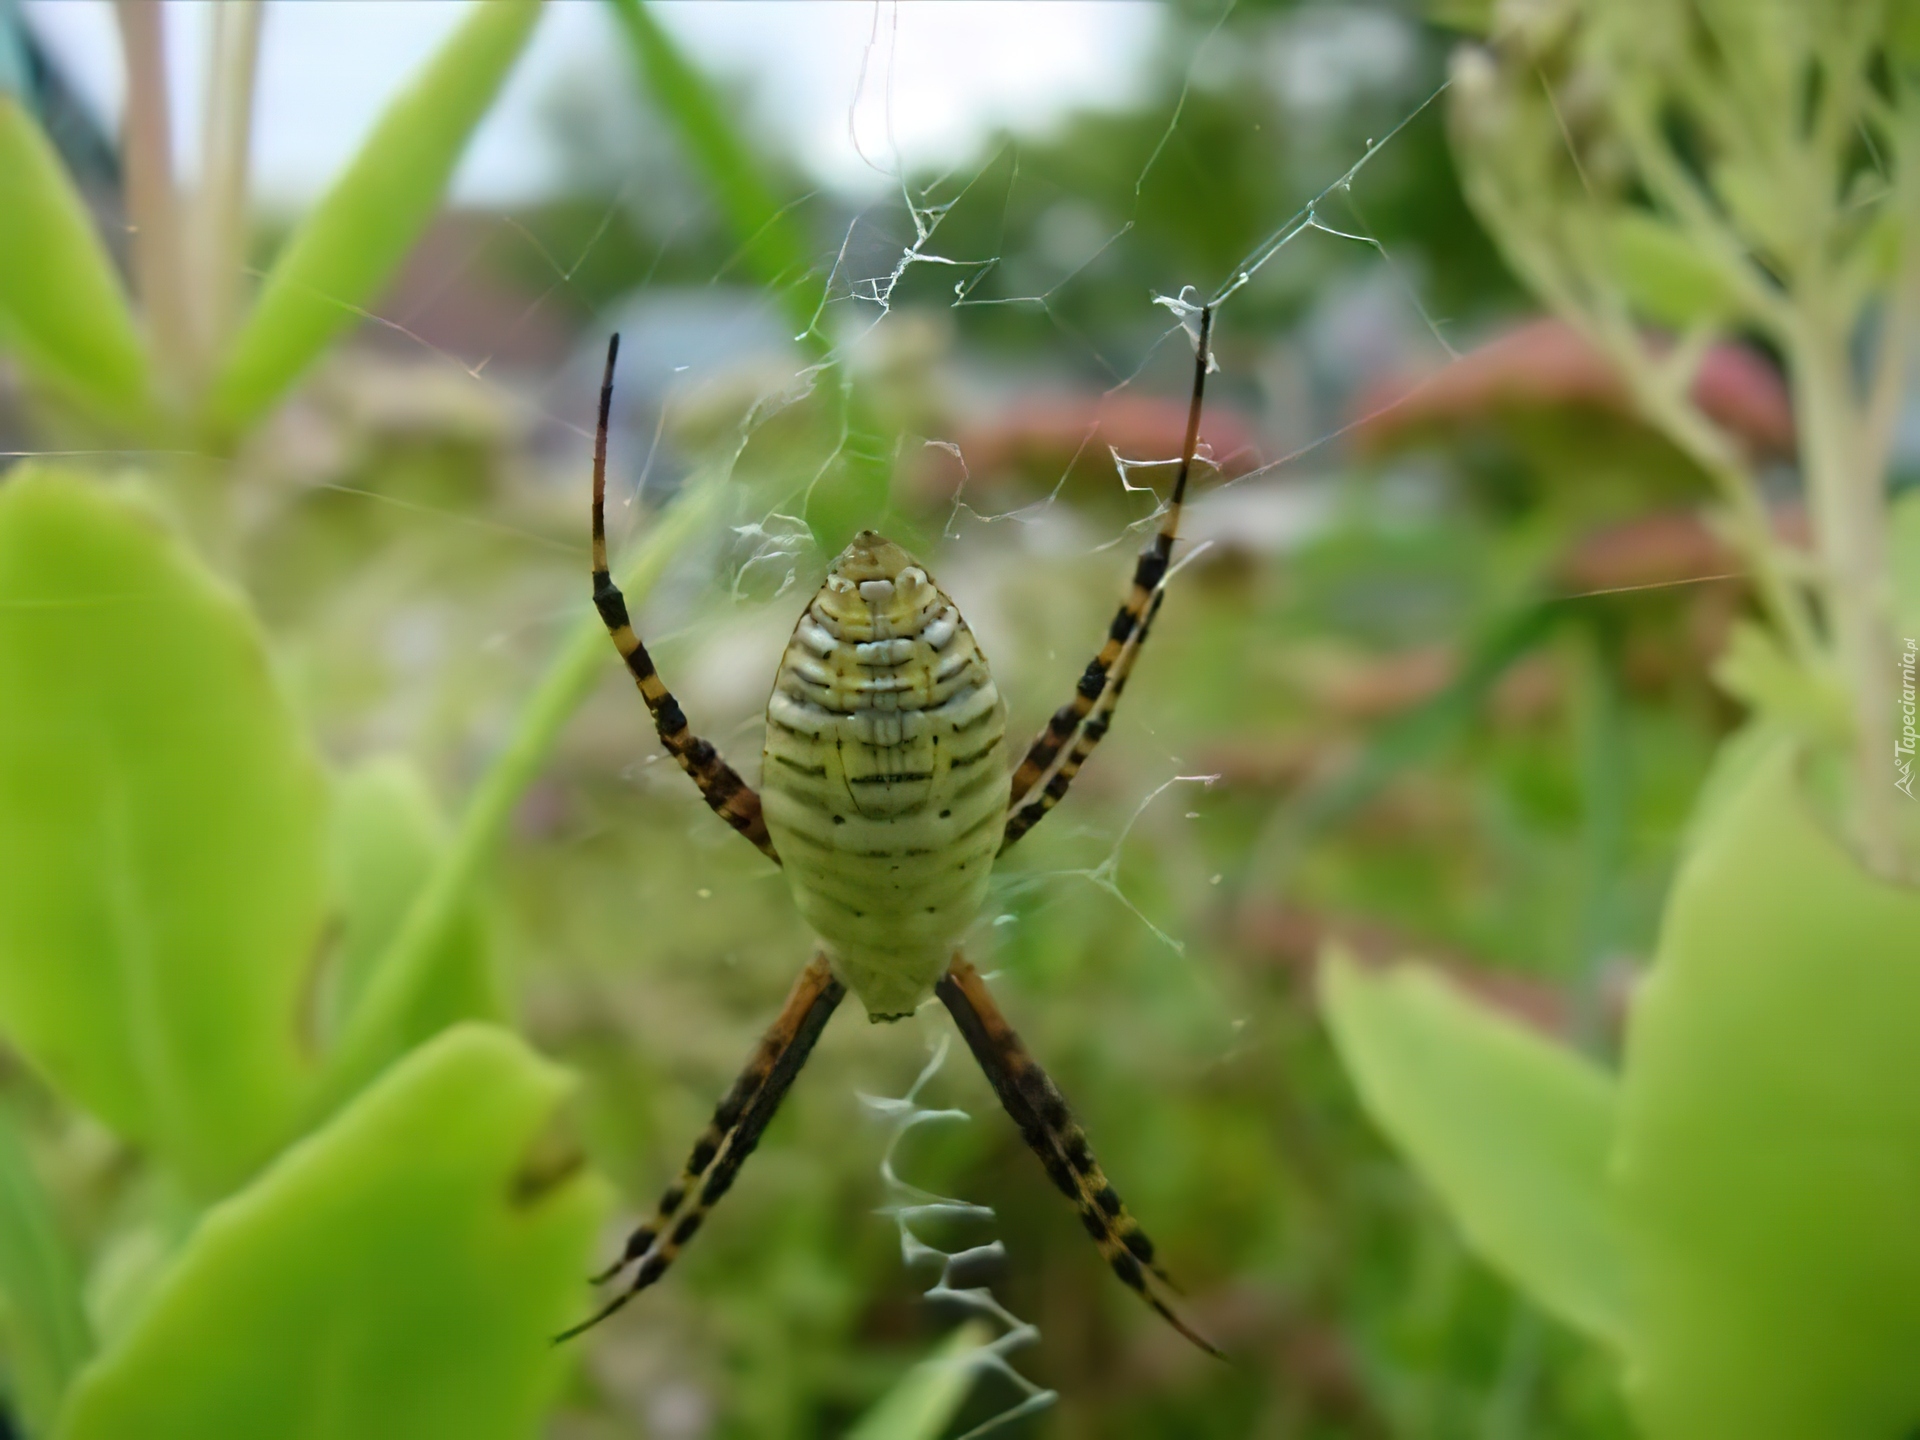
760 530 1008 1020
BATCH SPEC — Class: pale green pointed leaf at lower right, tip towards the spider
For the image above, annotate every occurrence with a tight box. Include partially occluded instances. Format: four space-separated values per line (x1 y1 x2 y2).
1321 952 1632 1352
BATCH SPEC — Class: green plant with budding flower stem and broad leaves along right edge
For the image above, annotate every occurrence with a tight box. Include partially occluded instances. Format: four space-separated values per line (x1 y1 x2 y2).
1327 0 1920 1440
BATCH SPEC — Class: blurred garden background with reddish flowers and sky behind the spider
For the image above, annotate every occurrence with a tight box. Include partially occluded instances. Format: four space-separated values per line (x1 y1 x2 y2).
0 0 1873 1440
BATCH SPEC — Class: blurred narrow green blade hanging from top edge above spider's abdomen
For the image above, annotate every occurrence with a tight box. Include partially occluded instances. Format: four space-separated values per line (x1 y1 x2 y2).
612 0 902 555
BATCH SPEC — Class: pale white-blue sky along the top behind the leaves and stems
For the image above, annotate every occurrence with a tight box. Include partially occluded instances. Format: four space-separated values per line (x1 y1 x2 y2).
23 0 1164 205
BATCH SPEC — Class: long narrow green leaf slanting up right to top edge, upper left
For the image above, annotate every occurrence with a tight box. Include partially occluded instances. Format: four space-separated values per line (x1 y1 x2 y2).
204 0 540 436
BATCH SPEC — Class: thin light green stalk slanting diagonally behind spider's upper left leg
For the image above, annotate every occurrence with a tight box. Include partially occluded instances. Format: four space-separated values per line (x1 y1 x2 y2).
311 470 726 1119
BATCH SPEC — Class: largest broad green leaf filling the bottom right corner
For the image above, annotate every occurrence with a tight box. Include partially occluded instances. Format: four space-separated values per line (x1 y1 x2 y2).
1615 745 1920 1440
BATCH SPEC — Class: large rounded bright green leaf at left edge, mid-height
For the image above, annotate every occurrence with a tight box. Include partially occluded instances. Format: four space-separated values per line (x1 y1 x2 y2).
0 467 324 1194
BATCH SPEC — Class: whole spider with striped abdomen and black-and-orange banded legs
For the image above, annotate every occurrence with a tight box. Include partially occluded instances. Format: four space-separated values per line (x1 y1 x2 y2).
559 309 1219 1356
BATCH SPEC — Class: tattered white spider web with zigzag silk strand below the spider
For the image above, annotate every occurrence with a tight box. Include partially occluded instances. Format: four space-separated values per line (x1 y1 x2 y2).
0 2 1455 1434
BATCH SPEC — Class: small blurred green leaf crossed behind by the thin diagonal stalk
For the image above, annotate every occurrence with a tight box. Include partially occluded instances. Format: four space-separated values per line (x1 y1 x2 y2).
321 756 507 1048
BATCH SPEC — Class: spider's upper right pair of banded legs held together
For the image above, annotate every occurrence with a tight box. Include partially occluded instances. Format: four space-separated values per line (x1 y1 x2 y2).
1000 305 1213 854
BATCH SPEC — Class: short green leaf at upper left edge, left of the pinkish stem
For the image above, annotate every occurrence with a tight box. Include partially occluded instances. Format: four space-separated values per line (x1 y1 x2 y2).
0 90 148 428
